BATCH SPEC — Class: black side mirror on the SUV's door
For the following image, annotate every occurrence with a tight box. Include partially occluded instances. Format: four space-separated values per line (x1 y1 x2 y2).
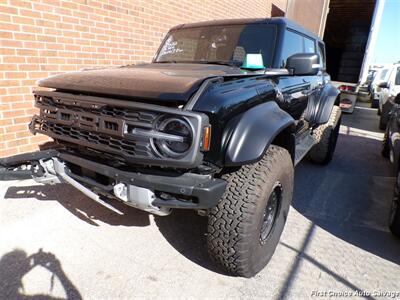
286 53 321 75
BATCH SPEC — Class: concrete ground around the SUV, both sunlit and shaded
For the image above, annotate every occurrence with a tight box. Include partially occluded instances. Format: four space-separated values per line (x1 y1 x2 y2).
0 104 400 299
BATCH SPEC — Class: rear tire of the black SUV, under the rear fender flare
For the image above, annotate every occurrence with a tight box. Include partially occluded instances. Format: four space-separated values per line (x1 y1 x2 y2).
309 105 341 165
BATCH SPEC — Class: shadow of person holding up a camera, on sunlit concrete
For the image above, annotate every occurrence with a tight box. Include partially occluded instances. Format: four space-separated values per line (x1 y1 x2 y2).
0 249 82 300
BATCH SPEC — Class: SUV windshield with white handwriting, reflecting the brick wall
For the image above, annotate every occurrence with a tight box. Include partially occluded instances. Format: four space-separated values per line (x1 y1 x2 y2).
155 24 276 68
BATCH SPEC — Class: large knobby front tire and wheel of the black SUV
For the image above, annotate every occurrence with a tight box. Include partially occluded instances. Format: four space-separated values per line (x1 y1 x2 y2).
207 145 294 278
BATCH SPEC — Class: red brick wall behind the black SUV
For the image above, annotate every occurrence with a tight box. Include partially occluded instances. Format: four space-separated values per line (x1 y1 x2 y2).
0 0 286 157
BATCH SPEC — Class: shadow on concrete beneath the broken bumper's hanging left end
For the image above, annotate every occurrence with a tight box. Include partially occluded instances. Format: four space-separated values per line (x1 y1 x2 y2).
4 184 150 227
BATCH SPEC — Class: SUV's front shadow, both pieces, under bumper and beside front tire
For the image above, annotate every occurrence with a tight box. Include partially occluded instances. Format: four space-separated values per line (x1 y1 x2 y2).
5 184 220 273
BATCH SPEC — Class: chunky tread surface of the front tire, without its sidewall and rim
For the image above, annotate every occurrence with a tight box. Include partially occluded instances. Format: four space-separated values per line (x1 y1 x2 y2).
207 145 293 277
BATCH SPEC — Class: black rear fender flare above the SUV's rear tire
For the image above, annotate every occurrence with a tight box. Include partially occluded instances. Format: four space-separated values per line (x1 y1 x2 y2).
305 83 340 125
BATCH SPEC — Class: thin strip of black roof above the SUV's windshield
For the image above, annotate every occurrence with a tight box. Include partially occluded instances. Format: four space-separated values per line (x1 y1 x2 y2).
171 17 321 40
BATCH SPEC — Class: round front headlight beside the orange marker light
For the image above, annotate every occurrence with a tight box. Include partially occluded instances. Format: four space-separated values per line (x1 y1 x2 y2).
155 117 193 158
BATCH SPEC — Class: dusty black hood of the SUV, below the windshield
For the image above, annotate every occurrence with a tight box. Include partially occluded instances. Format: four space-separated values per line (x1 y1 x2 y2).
38 63 247 102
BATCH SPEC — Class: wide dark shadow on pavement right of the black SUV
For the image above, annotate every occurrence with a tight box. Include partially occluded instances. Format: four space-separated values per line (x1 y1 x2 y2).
292 130 400 264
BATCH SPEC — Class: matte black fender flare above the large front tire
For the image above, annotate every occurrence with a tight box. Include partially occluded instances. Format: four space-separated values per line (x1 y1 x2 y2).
225 101 294 166
